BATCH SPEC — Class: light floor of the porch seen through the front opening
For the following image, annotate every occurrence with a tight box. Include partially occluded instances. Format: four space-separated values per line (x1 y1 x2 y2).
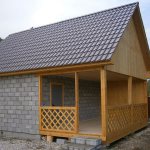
79 118 101 134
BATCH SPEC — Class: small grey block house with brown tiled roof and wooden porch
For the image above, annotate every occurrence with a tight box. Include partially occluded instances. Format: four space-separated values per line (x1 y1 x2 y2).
0 3 150 143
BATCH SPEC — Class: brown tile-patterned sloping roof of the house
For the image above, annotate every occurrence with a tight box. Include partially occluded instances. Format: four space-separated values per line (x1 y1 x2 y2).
0 3 138 72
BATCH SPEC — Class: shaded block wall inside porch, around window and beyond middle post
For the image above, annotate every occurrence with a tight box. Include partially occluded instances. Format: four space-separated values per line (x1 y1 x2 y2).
43 76 100 120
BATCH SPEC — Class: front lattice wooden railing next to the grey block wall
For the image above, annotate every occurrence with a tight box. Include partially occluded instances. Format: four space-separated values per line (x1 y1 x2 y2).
40 106 76 132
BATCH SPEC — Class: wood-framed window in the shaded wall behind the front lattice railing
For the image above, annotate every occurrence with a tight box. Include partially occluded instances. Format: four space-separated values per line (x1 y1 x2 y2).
50 83 64 106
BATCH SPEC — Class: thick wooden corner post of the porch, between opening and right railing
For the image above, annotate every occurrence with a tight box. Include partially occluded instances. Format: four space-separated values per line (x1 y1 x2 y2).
100 67 107 141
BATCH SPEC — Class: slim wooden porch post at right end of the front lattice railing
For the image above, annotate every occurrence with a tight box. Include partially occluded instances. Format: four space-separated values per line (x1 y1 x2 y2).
75 72 79 133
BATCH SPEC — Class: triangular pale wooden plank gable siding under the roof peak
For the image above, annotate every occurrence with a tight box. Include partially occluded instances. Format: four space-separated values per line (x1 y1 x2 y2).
107 19 146 79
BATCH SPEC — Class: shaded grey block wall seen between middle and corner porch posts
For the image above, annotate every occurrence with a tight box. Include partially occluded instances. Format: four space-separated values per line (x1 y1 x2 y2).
79 80 101 120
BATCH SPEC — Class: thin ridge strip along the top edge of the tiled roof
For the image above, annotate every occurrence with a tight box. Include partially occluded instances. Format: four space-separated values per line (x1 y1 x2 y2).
6 2 139 38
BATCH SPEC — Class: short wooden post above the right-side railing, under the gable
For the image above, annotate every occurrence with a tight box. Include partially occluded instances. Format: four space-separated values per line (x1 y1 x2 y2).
128 76 133 105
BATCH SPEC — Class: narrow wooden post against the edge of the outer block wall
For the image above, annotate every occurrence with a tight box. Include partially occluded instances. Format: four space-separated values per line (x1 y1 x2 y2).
38 76 42 130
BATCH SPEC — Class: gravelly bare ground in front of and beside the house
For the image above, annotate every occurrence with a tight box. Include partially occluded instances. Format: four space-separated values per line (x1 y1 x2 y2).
0 122 150 150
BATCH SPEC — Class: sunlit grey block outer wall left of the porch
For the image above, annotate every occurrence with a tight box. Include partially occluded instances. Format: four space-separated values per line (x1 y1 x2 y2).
0 75 39 138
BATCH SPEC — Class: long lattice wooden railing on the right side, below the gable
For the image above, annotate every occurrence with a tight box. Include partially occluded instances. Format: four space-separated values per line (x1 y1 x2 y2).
107 104 147 142
